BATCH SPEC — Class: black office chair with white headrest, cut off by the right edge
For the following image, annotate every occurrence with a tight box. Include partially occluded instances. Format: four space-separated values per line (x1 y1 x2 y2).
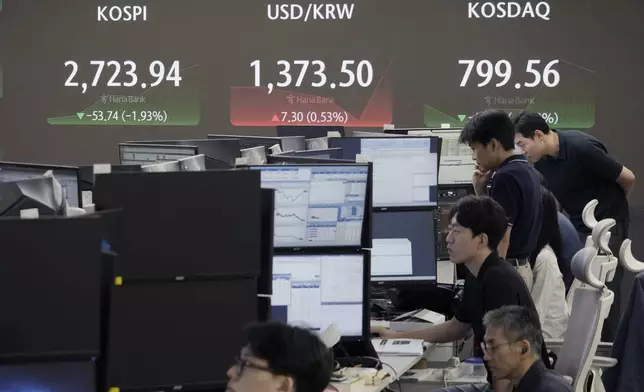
602 239 644 392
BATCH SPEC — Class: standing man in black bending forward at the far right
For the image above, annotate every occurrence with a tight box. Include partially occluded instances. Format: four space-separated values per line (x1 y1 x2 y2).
514 112 635 342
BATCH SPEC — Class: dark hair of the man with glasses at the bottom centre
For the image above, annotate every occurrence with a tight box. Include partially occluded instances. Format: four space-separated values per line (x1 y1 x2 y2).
247 322 333 392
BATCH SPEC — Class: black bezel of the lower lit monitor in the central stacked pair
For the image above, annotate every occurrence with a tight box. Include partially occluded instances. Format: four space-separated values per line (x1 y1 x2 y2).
271 248 371 342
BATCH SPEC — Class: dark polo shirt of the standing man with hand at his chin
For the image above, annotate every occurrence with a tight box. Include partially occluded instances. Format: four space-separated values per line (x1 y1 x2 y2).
489 155 543 258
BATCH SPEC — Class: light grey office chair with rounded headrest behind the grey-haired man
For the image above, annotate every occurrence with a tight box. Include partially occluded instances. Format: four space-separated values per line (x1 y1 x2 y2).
546 247 617 392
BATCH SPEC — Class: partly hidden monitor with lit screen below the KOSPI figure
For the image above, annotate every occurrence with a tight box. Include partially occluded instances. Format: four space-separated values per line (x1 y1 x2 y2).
119 143 199 166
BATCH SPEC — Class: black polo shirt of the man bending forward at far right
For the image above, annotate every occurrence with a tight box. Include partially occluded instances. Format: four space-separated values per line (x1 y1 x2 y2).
535 130 629 234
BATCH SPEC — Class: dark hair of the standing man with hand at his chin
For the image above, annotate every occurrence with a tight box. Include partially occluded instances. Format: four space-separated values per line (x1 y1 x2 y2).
458 109 514 151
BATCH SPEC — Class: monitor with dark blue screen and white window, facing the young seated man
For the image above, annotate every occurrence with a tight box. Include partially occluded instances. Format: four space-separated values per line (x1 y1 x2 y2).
371 210 437 282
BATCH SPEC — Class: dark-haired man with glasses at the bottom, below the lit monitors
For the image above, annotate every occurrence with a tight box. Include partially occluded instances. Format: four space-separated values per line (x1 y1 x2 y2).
226 322 333 392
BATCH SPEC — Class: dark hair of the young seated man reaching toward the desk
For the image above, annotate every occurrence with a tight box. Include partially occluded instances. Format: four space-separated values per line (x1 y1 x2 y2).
449 196 508 250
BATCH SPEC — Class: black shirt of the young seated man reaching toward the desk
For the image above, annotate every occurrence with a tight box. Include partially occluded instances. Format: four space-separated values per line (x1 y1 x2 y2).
454 252 550 383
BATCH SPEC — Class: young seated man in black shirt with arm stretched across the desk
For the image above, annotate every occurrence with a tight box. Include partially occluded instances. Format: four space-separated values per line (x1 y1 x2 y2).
373 196 549 392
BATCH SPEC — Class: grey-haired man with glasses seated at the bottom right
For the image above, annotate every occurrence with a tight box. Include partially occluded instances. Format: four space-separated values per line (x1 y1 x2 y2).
481 305 572 392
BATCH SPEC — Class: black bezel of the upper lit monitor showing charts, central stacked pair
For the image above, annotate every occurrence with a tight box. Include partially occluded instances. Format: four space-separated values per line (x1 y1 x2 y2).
247 162 373 254
